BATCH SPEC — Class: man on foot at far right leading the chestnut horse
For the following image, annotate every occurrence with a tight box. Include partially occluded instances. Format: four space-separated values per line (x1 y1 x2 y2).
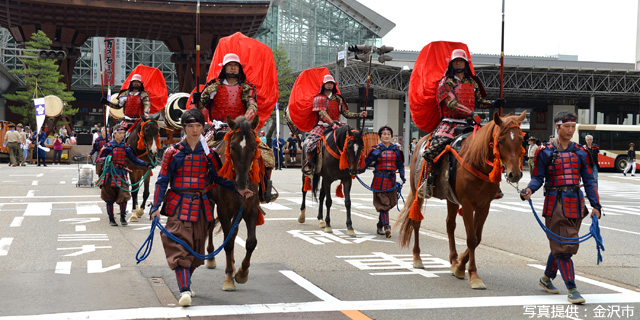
522 111 602 304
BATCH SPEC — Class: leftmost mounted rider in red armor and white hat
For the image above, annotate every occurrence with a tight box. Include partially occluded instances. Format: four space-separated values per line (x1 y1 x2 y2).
100 74 151 132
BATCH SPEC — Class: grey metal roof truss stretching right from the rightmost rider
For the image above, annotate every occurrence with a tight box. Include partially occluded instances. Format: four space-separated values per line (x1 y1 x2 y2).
475 66 640 102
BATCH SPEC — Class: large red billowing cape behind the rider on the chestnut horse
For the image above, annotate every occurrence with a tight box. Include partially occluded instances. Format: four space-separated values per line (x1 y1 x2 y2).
409 41 475 132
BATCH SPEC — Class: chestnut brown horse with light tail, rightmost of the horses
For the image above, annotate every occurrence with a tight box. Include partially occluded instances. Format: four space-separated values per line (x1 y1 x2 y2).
395 112 526 289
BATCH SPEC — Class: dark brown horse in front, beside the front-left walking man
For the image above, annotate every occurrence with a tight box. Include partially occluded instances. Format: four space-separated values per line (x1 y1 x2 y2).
205 116 264 291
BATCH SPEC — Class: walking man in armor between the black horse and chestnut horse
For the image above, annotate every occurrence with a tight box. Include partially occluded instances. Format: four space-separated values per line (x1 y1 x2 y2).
360 126 406 238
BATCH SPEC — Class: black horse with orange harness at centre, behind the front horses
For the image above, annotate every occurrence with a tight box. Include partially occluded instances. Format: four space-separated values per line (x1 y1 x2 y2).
298 125 364 236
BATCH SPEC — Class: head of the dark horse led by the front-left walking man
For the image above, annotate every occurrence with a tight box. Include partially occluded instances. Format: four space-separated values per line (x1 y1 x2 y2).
225 116 260 190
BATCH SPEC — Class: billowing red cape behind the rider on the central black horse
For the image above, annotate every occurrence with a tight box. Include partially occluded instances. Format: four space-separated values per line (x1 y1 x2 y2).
287 67 340 132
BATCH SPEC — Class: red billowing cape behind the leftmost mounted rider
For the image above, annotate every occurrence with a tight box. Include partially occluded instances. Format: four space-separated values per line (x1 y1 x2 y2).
120 64 168 114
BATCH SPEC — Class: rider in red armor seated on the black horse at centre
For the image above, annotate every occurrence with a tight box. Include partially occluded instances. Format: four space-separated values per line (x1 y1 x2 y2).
302 74 367 175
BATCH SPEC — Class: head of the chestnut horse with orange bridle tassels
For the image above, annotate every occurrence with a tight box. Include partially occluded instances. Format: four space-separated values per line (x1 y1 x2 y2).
493 111 527 183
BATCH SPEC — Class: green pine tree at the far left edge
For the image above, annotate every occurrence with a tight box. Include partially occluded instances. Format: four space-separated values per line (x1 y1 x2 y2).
5 30 78 130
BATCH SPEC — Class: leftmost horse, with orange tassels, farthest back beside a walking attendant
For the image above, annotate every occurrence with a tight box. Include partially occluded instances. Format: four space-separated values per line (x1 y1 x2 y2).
127 120 160 221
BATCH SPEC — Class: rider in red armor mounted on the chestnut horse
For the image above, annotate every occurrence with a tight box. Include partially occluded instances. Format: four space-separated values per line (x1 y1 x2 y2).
422 49 505 198
